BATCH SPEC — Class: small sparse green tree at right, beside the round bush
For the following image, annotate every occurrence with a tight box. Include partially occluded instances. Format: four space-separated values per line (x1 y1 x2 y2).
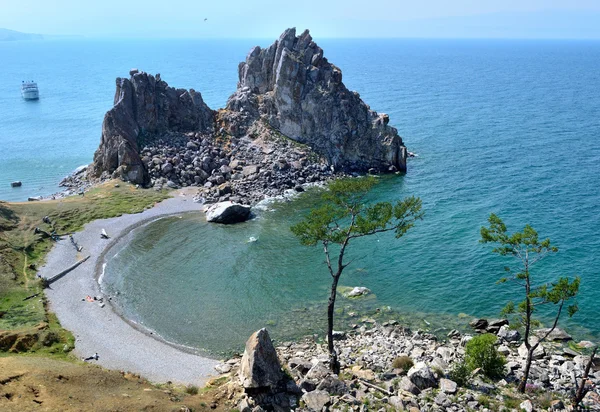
480 213 580 393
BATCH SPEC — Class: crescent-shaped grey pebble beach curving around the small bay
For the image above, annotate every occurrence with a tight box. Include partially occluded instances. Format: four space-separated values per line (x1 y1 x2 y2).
39 190 218 385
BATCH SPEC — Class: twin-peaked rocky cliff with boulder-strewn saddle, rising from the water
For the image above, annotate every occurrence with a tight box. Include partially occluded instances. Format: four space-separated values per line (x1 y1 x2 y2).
91 29 406 189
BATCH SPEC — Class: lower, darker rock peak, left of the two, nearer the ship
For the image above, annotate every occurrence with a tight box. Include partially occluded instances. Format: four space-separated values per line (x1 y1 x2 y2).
91 70 214 185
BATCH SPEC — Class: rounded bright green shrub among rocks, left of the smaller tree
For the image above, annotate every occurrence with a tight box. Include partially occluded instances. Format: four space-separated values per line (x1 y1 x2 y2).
465 333 506 379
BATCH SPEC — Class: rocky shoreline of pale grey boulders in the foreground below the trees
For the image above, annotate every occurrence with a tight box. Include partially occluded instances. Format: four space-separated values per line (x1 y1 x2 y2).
210 319 600 412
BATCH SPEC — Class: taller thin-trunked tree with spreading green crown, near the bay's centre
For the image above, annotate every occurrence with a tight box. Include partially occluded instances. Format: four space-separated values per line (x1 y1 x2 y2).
291 177 423 373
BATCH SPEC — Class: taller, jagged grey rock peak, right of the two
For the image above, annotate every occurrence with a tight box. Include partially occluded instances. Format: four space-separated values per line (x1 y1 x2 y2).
224 29 406 171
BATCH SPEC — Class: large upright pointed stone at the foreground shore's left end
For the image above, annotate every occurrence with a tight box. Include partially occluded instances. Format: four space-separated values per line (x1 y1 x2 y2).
239 328 284 389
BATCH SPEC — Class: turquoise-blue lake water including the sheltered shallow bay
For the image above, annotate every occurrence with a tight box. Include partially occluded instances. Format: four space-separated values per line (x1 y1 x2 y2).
0 40 600 353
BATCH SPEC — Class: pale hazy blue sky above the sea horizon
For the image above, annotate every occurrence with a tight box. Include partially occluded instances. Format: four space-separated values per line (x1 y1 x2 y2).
0 0 600 39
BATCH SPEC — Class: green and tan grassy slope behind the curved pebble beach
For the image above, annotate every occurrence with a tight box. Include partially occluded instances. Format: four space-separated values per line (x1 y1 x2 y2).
0 182 168 356
